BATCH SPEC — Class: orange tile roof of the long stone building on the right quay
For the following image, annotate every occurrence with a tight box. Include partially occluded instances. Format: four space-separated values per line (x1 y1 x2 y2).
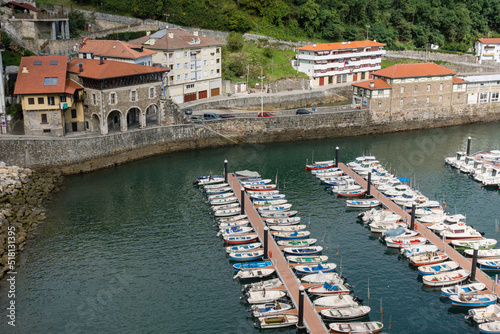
373 63 455 78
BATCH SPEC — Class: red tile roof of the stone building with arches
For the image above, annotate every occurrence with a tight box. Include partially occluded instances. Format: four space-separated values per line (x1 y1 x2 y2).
68 58 168 79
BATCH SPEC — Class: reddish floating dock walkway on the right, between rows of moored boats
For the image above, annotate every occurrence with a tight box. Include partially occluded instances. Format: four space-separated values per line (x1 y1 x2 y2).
339 163 500 296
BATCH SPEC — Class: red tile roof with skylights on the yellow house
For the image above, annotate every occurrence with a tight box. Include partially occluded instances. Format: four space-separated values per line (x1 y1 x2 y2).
14 56 68 95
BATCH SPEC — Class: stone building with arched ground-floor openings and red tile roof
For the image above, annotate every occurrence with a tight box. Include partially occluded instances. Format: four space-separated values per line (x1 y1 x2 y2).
68 57 170 135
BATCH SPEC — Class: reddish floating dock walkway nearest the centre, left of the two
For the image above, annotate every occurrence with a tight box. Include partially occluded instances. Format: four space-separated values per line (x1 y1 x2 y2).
227 173 329 334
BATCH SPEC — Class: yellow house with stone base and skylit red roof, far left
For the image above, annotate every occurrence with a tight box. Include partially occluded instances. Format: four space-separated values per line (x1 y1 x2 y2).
14 56 84 136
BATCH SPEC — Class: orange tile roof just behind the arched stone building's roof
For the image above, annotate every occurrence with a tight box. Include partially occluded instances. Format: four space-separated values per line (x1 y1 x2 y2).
79 39 156 59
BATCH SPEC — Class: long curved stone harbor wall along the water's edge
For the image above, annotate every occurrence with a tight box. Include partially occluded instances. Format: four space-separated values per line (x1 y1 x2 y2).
0 106 500 174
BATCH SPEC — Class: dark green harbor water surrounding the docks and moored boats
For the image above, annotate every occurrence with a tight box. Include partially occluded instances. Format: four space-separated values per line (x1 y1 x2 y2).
0 122 500 334
